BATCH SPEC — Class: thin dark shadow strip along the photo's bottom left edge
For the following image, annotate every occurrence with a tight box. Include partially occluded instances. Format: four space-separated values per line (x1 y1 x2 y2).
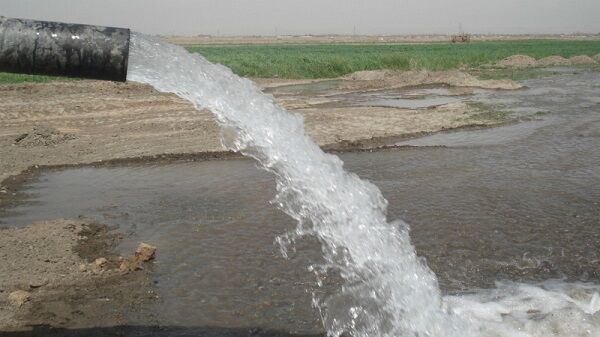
0 325 325 337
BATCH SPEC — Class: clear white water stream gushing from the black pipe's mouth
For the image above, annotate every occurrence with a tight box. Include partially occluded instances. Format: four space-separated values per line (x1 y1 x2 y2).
128 34 600 337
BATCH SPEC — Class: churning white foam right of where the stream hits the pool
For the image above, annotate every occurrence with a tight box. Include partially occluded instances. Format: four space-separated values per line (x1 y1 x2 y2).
444 280 600 337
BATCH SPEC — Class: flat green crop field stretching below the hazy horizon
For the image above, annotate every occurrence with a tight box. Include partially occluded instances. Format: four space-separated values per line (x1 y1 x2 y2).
0 40 600 84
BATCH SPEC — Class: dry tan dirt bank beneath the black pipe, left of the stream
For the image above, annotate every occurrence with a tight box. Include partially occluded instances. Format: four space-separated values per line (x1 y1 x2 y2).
0 81 222 186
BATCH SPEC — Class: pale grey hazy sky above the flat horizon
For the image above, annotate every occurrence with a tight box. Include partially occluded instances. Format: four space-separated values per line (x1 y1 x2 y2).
0 0 600 35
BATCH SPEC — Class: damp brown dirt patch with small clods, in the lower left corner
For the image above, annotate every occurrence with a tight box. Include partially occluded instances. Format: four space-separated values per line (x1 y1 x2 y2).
0 220 155 330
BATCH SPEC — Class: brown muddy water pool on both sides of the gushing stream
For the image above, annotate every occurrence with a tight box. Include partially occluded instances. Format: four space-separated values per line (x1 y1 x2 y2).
0 68 600 333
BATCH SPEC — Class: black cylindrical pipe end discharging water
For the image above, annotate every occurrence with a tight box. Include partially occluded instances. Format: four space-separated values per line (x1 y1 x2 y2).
0 16 130 82
